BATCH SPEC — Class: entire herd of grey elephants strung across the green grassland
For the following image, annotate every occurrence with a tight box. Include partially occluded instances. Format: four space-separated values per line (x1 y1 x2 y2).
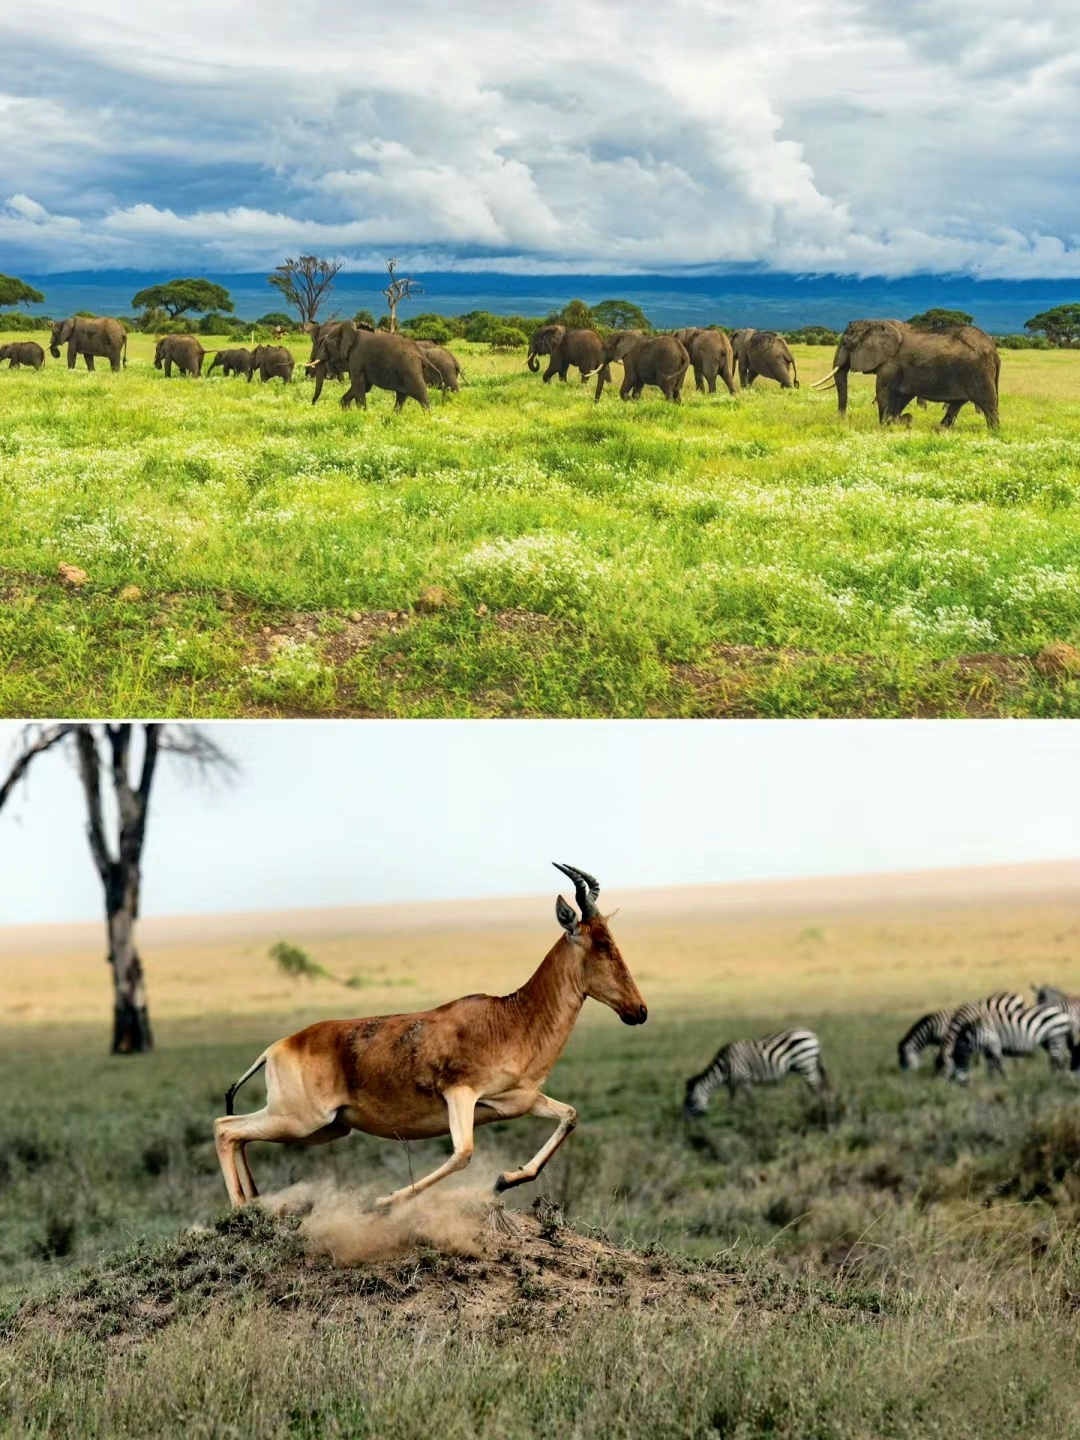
0 315 1001 429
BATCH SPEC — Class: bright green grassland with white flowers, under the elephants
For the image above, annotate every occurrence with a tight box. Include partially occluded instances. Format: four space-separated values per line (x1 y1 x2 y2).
0 336 1080 716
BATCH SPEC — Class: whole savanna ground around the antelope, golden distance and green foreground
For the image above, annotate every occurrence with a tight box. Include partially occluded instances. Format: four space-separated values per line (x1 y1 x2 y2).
0 865 1080 1440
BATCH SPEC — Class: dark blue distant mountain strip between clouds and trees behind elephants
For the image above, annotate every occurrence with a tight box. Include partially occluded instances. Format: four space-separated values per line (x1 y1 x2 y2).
16 271 1080 334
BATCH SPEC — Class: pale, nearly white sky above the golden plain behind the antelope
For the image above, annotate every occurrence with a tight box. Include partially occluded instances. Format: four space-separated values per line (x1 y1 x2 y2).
0 720 1080 924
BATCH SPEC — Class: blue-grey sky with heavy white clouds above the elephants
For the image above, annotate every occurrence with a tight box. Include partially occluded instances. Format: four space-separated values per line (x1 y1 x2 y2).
0 0 1080 278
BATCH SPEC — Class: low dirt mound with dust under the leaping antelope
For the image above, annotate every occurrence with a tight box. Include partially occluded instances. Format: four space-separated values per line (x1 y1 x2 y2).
8 1191 744 1348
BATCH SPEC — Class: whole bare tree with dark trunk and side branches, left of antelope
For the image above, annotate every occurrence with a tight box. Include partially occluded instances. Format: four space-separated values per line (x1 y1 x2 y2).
0 723 235 1056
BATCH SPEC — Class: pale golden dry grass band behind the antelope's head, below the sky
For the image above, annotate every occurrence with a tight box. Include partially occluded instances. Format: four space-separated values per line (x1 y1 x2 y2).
8 861 1080 1028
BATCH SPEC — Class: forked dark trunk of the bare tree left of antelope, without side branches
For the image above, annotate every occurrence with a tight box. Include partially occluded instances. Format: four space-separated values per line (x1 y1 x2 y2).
75 724 160 1056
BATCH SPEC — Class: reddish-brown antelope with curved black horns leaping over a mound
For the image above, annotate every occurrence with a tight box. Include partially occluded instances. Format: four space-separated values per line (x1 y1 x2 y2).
215 864 648 1205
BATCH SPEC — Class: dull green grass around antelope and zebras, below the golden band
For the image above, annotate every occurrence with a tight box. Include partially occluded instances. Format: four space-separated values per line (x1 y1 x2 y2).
0 1014 1080 1440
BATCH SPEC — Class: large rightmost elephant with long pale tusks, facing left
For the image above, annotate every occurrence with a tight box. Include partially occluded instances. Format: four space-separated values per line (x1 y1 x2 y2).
815 320 1001 431
